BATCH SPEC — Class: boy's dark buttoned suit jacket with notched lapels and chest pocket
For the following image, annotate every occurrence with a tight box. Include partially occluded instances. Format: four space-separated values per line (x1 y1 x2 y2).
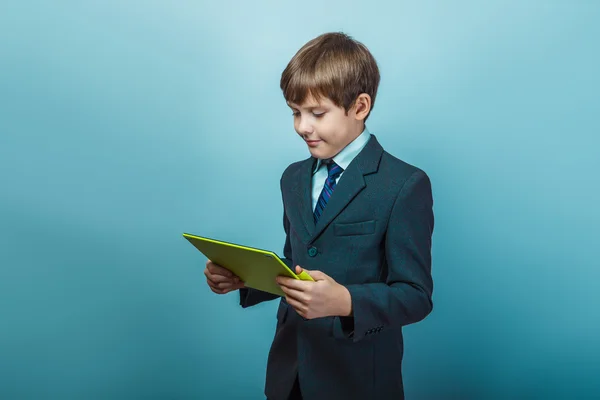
240 135 434 400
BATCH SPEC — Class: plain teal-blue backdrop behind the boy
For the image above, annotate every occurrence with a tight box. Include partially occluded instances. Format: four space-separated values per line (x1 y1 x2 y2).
0 0 600 399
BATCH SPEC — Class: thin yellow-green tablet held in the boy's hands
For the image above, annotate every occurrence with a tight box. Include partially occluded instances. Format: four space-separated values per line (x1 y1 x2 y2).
183 233 314 296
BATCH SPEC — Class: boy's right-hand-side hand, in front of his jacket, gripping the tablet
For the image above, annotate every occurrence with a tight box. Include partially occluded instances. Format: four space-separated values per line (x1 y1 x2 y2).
277 265 352 319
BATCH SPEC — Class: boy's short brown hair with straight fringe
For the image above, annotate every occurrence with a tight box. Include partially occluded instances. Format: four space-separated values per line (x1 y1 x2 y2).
280 32 380 121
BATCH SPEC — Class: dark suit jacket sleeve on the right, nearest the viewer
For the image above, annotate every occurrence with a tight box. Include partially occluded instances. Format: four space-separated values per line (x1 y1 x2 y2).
334 170 434 342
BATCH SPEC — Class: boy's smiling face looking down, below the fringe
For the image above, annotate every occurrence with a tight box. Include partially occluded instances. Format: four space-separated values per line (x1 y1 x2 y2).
288 97 364 159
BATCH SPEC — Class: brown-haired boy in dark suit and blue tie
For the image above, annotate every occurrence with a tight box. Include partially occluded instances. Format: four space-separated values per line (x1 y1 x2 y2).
205 33 434 400
